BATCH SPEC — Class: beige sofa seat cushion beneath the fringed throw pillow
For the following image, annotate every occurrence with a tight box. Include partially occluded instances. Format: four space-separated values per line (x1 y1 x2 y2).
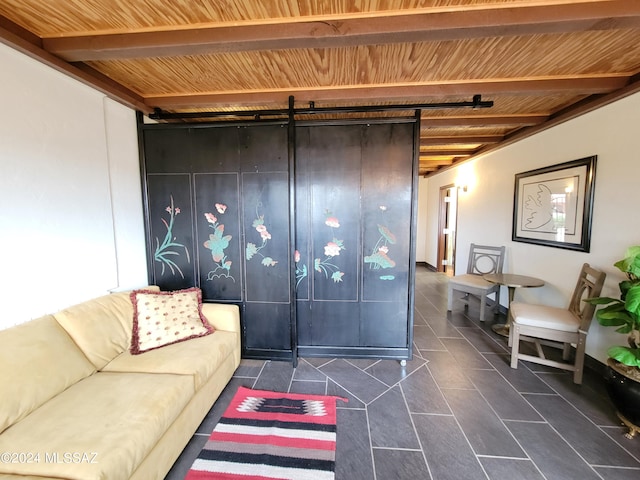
103 330 239 390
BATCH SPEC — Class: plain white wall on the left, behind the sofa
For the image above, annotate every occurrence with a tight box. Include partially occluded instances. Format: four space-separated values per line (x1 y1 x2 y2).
0 44 147 329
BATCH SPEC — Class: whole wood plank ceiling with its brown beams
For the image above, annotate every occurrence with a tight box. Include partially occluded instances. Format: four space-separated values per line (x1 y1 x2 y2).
0 0 640 175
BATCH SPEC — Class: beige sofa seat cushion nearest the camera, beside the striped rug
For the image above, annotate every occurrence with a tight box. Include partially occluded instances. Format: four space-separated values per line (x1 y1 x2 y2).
0 372 194 480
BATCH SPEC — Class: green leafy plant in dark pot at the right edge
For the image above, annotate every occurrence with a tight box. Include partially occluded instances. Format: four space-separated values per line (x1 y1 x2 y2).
586 245 640 437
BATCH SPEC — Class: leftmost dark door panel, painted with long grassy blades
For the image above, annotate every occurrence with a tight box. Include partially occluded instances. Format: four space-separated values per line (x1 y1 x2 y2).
147 174 195 290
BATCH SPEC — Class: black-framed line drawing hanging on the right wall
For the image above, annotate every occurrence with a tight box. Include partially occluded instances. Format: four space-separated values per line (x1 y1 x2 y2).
511 155 598 253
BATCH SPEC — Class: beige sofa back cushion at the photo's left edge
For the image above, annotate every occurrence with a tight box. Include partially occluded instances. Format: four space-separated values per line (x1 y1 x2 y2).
0 315 95 436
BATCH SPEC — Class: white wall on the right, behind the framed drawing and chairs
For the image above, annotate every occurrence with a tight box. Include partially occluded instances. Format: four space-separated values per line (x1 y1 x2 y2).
419 94 640 362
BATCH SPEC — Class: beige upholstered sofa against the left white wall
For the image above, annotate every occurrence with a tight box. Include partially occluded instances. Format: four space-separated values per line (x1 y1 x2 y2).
0 293 240 480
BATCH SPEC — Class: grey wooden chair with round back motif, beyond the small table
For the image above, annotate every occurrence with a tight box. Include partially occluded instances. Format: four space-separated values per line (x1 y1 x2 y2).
447 243 504 322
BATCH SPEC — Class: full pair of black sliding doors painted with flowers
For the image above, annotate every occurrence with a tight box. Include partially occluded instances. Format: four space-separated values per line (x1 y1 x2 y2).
141 121 417 359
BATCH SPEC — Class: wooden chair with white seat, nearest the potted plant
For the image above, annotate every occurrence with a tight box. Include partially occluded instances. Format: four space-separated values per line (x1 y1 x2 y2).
509 263 606 384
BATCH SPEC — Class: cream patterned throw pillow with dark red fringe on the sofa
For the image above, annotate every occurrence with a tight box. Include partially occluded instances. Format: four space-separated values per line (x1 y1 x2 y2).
130 287 213 355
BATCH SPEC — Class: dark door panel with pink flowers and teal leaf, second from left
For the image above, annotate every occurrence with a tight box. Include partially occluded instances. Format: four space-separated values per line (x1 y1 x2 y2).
193 173 243 302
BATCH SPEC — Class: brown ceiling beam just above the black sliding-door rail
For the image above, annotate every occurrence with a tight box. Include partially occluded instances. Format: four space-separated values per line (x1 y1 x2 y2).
146 75 628 109
